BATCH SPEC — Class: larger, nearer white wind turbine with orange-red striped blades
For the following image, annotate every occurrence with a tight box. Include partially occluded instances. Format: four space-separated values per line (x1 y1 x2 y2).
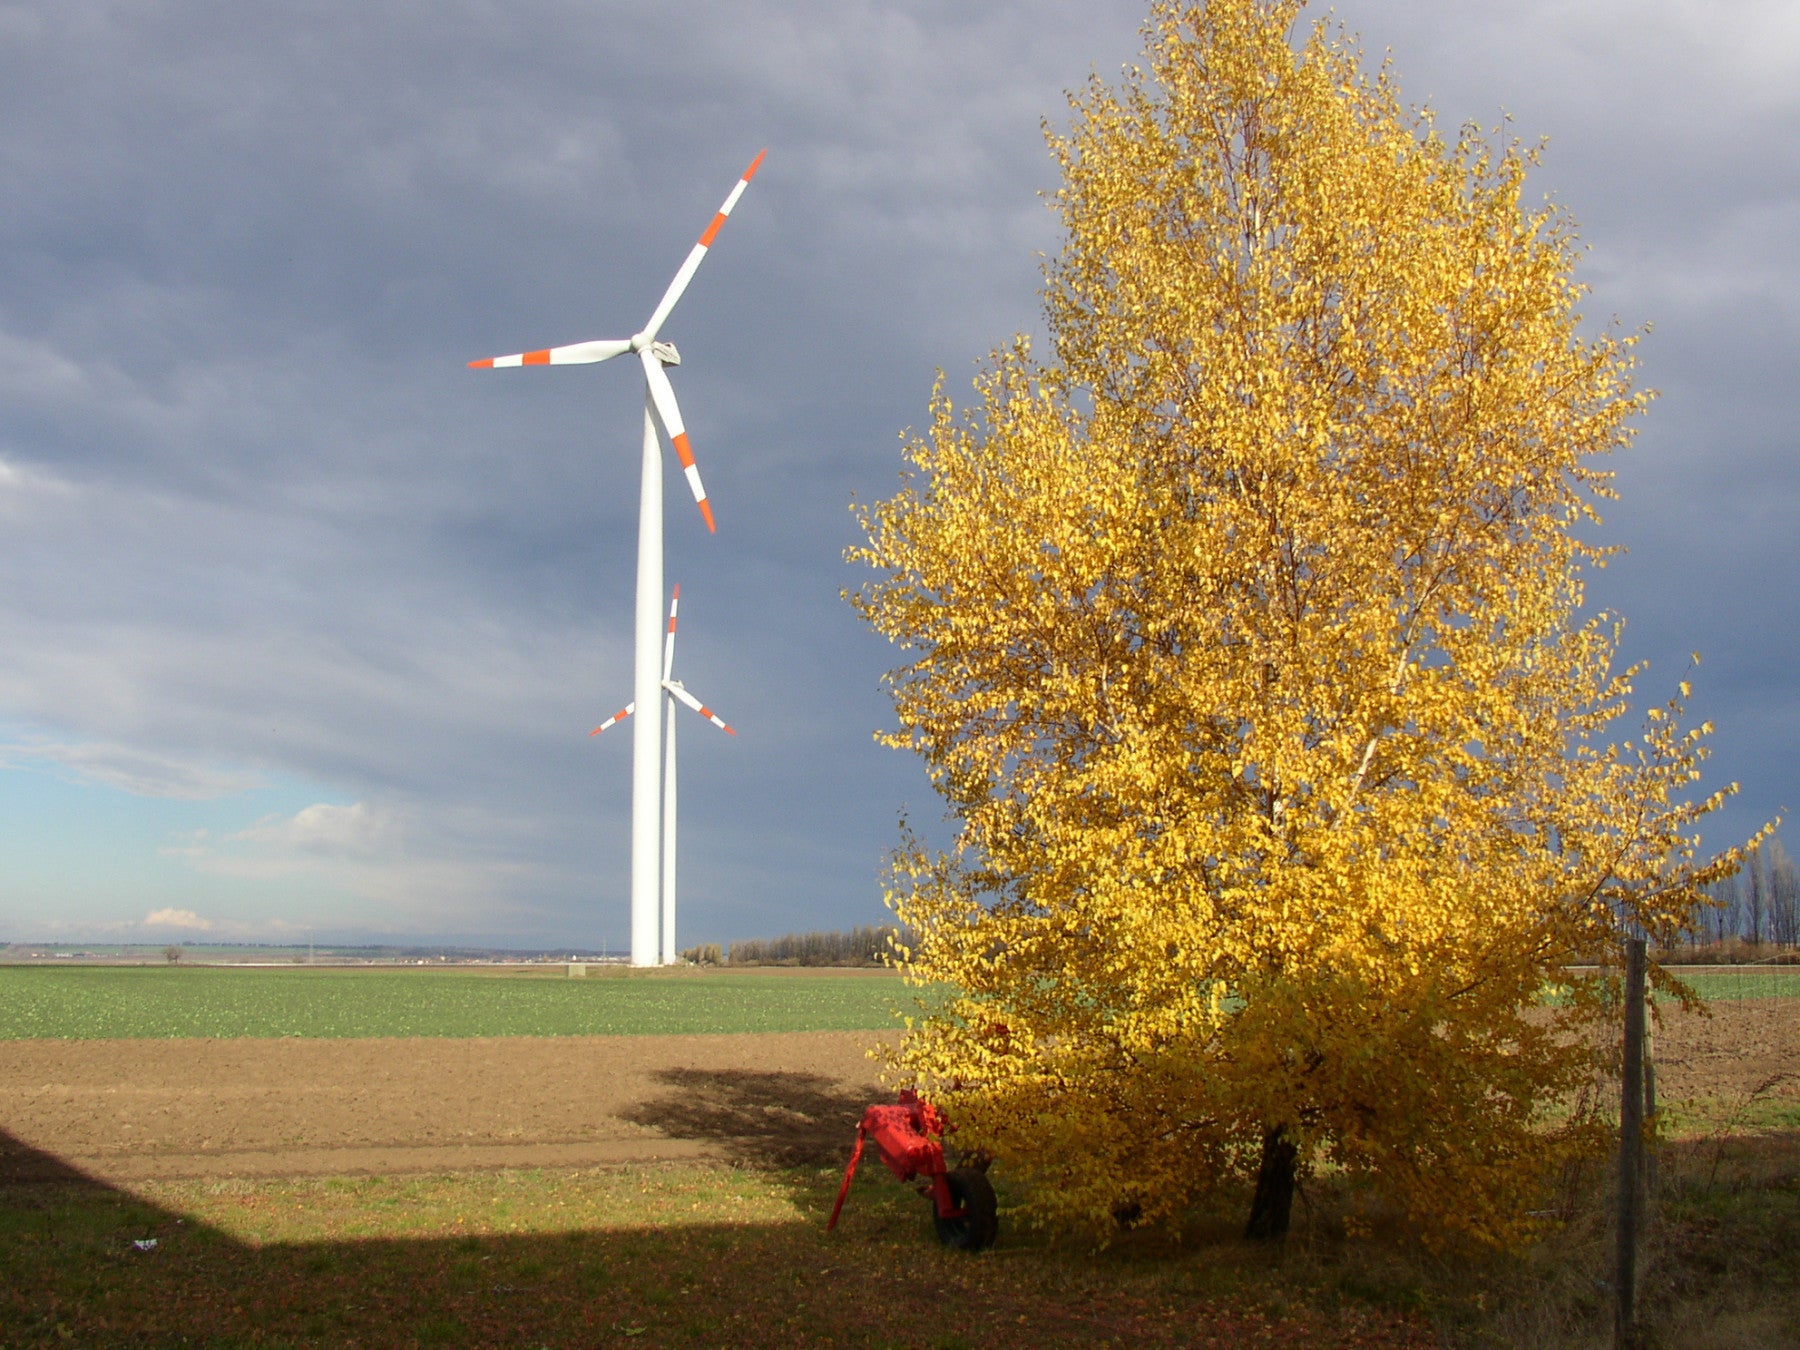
470 151 767 965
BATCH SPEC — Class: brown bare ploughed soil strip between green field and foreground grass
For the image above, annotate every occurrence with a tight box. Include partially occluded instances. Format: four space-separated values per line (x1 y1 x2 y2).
0 999 1800 1183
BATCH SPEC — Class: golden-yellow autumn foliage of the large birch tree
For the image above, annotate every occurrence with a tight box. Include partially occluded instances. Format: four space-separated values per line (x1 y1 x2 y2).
851 0 1756 1242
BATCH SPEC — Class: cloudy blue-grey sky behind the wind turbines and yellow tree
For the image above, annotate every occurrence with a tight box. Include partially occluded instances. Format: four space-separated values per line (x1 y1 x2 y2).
0 0 1800 949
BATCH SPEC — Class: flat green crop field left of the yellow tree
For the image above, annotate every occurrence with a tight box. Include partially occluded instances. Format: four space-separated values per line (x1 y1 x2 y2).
0 967 909 1040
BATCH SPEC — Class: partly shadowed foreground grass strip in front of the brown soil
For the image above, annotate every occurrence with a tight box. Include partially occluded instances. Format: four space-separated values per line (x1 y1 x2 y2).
0 1134 1800 1350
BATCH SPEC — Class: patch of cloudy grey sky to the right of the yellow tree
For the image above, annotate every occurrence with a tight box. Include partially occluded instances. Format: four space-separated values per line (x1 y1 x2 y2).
1388 0 1800 842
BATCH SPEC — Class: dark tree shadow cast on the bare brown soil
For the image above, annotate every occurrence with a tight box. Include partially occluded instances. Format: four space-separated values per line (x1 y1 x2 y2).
619 1069 875 1166
